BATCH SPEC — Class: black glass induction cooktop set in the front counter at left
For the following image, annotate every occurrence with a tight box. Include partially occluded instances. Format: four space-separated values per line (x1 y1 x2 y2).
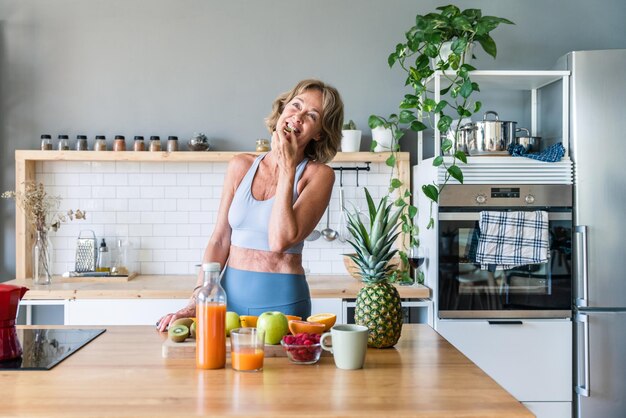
0 328 105 370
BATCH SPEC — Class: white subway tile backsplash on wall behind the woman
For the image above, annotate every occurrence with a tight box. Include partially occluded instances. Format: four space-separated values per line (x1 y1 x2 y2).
35 161 390 274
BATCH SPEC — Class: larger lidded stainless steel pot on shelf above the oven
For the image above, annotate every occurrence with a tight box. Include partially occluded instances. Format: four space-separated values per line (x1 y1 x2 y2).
456 110 517 155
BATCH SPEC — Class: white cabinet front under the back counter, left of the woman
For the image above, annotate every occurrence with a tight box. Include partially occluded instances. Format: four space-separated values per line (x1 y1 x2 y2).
64 299 189 325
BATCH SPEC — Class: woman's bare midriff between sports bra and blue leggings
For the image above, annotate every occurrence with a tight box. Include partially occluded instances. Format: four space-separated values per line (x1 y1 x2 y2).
228 245 304 274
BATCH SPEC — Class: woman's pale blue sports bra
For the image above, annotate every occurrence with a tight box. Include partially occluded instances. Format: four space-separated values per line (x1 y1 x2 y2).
228 154 308 254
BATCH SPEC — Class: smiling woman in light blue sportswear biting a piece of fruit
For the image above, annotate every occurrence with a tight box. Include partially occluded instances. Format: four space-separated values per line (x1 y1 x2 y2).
157 80 343 331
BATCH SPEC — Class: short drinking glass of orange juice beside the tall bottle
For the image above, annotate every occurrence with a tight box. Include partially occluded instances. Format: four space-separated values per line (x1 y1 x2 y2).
230 328 265 372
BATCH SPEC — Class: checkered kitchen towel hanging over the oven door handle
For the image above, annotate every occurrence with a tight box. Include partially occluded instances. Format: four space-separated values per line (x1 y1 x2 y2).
476 211 549 271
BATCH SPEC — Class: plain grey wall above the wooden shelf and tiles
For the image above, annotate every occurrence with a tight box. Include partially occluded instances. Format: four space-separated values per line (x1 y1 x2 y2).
0 0 626 281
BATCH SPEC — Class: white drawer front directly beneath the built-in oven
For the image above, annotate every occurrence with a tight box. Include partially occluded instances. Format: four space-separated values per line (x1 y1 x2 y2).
436 319 572 417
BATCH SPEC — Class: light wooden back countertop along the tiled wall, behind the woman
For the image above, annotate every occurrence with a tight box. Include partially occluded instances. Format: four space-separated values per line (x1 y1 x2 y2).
5 275 430 300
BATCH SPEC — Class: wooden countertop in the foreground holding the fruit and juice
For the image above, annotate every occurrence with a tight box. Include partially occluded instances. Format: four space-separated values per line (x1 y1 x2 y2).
0 325 533 418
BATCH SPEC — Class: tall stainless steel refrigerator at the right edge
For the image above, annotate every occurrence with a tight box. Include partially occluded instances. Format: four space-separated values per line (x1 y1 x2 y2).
560 49 626 418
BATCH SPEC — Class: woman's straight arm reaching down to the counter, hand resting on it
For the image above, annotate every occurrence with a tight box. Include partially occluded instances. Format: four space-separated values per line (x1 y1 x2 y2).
157 154 253 332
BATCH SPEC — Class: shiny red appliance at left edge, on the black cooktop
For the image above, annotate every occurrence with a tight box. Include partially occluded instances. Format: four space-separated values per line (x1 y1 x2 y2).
0 284 28 361
